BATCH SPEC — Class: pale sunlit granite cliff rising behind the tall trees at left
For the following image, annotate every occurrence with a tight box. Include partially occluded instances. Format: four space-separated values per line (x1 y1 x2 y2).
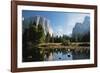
22 16 53 36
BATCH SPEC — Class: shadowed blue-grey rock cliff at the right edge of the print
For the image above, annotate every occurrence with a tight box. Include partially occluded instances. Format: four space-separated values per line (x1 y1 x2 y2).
72 16 90 38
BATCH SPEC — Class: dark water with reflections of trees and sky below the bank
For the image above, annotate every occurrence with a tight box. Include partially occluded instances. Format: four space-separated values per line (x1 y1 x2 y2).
23 48 90 62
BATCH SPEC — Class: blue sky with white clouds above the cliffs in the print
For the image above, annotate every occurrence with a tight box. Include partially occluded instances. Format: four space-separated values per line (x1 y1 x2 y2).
22 10 90 36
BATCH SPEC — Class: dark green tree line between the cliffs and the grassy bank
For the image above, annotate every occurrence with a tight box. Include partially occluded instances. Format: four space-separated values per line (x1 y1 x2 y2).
23 22 90 45
